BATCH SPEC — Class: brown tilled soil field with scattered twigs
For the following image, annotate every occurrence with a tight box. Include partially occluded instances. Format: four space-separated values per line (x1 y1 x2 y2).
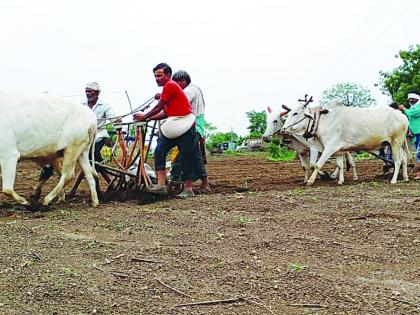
0 156 420 314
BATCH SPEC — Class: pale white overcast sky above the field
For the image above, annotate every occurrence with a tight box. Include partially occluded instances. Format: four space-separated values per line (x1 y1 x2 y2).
0 0 420 135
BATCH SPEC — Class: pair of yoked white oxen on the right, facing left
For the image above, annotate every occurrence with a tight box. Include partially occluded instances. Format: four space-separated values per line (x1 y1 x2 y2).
263 101 408 185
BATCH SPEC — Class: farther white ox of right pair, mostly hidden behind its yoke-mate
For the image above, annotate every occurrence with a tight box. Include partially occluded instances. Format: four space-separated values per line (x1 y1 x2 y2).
263 107 358 185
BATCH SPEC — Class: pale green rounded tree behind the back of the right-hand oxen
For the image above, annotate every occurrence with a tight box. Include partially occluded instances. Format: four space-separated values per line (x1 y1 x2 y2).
319 83 376 107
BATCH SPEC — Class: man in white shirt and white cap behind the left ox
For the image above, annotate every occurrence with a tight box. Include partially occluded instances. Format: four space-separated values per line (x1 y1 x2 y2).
68 81 121 197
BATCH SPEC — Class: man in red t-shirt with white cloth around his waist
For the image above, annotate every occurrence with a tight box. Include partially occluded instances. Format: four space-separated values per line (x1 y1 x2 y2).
133 63 195 198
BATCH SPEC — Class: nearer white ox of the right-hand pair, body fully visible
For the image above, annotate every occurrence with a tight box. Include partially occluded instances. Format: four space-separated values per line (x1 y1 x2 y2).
283 101 408 185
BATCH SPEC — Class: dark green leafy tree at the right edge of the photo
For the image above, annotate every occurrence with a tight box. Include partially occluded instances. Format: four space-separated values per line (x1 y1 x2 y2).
379 45 420 104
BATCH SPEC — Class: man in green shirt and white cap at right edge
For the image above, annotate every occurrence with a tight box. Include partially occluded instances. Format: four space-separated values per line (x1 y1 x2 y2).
398 90 420 180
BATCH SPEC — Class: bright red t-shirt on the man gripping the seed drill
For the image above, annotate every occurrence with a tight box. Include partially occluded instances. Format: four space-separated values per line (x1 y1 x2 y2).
160 80 192 117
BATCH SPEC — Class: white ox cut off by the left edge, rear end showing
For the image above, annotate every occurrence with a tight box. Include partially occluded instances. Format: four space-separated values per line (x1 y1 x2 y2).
0 94 99 206
